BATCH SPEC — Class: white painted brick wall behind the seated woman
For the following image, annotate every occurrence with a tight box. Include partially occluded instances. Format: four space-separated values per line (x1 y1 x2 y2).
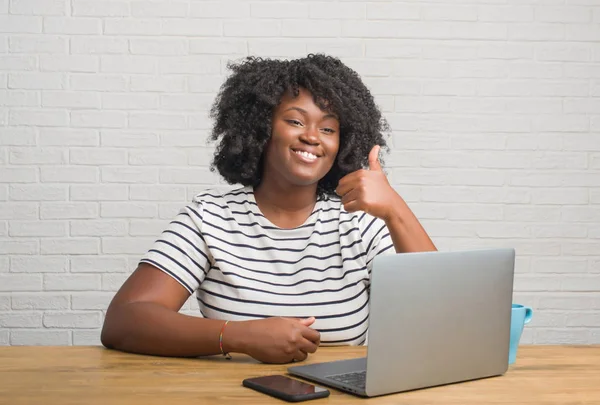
0 0 600 345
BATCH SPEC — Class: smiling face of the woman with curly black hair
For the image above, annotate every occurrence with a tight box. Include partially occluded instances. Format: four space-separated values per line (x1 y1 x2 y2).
263 88 340 186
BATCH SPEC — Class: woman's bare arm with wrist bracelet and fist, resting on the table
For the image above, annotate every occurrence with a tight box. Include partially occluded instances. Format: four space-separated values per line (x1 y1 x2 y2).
101 263 320 363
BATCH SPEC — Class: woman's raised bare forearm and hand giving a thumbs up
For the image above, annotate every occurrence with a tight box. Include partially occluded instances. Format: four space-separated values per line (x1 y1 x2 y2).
335 145 437 253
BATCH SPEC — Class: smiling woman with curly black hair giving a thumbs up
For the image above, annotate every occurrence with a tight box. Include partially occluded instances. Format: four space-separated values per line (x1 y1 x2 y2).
102 55 435 363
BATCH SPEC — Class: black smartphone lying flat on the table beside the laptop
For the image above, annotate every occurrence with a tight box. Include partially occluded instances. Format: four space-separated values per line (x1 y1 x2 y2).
242 375 329 402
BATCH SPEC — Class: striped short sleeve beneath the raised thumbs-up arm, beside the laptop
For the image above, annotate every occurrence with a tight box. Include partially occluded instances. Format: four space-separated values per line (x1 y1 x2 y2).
358 212 396 274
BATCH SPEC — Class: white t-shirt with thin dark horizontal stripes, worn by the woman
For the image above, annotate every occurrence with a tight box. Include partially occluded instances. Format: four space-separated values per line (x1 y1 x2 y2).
142 187 395 345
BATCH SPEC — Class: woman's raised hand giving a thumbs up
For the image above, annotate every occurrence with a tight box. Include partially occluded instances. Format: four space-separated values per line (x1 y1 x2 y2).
335 145 402 221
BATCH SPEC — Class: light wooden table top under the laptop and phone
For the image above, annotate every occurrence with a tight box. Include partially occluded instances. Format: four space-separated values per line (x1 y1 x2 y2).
0 346 600 405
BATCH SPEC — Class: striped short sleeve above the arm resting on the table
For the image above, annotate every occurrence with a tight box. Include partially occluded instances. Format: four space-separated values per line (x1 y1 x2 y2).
140 201 211 294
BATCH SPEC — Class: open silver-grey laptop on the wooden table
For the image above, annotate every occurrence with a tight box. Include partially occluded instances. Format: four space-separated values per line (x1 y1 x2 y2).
288 248 515 397
